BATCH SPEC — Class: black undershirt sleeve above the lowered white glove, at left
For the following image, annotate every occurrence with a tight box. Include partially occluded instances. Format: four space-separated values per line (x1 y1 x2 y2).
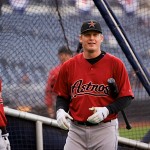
56 96 70 112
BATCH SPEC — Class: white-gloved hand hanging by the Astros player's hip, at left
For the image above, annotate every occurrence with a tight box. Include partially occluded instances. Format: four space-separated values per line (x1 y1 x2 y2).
56 109 73 130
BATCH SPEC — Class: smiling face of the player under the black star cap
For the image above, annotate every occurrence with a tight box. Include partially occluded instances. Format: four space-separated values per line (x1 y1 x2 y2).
80 31 103 53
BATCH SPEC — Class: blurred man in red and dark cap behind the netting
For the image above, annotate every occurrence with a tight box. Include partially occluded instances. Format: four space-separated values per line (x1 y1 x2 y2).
45 46 72 118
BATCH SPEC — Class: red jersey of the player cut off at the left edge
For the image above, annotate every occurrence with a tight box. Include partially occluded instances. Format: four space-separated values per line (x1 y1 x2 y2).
0 80 7 127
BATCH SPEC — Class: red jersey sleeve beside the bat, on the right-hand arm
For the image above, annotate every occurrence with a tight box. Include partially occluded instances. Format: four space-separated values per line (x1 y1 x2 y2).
114 56 134 97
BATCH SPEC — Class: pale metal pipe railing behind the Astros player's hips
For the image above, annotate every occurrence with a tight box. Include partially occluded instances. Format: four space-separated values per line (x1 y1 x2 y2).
4 107 150 150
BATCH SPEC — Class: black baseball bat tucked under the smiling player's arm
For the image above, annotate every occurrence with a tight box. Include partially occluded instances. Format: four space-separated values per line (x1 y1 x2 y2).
107 78 132 130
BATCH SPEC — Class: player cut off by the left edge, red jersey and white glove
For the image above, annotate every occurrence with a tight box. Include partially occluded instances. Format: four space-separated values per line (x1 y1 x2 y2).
0 80 10 150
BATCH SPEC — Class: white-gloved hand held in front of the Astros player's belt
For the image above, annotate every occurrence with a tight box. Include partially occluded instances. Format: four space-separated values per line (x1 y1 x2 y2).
87 107 109 124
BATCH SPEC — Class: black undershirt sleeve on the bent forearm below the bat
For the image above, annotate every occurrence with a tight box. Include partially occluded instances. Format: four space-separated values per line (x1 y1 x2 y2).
106 96 132 114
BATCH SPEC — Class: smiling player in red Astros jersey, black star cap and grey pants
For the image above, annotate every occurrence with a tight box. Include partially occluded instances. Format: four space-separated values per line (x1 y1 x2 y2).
54 20 134 150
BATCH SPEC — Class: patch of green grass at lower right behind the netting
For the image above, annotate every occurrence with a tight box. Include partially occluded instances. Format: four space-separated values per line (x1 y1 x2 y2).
119 126 150 140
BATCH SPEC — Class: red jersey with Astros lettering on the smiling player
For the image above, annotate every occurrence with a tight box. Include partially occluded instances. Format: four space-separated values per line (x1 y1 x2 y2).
54 53 133 121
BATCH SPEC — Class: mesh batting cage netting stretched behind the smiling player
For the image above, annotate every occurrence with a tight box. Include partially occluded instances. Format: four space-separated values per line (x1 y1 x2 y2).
0 0 150 150
